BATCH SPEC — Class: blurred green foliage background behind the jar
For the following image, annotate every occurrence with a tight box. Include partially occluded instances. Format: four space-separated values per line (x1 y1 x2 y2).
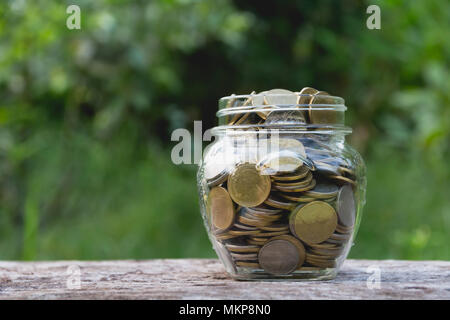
0 0 450 260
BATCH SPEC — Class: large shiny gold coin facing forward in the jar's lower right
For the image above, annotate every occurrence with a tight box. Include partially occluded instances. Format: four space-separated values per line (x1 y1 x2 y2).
289 201 337 243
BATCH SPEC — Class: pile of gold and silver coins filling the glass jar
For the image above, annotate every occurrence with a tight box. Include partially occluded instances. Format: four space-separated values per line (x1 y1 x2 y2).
205 88 356 275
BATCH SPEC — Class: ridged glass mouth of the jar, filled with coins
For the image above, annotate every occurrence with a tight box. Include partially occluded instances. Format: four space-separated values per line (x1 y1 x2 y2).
216 89 351 133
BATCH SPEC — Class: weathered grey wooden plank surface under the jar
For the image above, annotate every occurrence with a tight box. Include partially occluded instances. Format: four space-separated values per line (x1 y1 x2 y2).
0 259 450 300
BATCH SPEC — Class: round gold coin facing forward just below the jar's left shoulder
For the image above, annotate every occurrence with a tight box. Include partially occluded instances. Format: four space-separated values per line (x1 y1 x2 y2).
228 163 271 207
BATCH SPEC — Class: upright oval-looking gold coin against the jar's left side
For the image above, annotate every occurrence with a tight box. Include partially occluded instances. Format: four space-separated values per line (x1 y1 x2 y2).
207 187 235 231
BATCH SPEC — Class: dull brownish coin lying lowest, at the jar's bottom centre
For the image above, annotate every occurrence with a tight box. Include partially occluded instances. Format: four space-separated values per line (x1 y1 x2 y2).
258 240 300 274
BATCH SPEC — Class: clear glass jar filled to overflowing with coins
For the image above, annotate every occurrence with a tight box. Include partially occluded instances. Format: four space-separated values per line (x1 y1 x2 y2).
197 87 366 280
